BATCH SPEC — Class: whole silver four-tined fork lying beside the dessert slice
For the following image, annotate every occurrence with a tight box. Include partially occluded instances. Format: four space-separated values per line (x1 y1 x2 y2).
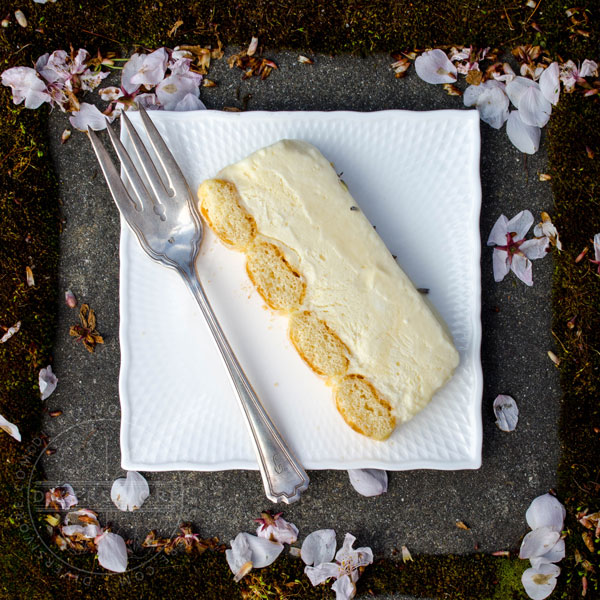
88 107 309 504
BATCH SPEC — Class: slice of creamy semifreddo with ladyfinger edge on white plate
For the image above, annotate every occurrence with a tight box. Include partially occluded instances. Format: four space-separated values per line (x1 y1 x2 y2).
198 140 459 440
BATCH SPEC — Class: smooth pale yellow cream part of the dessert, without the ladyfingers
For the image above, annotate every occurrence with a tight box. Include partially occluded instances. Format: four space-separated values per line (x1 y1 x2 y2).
217 140 459 423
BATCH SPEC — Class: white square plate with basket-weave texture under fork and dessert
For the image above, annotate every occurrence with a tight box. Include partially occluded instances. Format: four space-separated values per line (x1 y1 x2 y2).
119 111 482 471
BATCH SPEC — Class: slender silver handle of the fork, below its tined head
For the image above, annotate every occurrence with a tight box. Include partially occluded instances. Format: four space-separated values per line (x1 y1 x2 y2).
183 269 309 504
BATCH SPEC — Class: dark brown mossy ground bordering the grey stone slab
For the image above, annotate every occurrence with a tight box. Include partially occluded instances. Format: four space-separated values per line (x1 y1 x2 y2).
0 0 600 600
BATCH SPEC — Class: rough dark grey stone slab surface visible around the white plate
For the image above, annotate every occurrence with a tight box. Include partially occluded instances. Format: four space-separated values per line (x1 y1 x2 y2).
35 52 559 596
